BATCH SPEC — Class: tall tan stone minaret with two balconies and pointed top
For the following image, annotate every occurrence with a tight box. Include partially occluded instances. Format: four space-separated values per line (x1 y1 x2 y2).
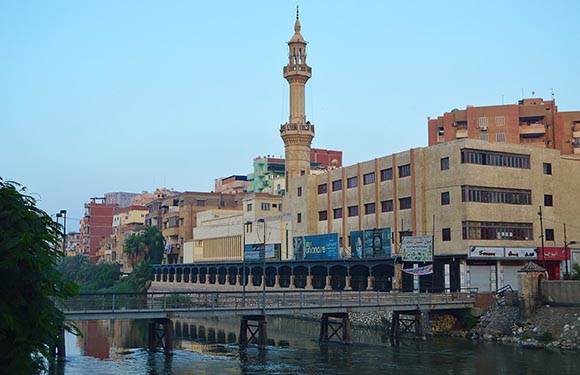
280 7 314 195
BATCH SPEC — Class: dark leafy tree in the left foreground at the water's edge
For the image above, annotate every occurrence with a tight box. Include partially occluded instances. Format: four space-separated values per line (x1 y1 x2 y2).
0 178 77 374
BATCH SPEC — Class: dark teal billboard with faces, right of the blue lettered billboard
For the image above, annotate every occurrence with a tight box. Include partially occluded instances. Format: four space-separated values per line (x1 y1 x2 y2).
350 228 391 259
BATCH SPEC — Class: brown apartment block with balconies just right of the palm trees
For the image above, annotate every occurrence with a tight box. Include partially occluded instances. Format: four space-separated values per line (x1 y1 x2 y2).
146 192 243 263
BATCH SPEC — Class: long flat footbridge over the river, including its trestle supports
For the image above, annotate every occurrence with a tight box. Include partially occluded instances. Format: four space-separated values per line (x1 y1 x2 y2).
62 289 474 354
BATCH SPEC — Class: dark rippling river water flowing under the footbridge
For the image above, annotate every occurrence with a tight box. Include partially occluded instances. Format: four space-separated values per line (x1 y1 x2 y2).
53 317 580 375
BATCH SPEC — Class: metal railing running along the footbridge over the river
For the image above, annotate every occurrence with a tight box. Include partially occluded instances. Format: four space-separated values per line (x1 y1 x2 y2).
63 290 473 313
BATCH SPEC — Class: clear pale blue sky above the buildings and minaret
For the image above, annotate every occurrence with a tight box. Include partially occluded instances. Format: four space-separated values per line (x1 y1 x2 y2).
0 0 580 229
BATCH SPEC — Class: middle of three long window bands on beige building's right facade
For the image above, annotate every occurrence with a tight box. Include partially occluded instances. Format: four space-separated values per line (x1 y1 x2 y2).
461 185 532 205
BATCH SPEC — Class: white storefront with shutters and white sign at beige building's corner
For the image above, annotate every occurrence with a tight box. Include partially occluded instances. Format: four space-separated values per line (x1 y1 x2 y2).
467 246 537 292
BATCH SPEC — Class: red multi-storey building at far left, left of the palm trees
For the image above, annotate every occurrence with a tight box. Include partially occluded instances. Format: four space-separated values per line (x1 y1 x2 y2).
80 198 119 263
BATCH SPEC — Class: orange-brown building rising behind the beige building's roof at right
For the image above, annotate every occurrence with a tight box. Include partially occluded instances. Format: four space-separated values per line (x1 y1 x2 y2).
428 98 580 155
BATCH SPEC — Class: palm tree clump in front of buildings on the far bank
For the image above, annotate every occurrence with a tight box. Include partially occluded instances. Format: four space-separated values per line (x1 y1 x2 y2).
124 227 165 266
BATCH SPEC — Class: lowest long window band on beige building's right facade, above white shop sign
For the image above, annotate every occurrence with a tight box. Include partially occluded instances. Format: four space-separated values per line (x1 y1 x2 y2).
463 221 534 241
